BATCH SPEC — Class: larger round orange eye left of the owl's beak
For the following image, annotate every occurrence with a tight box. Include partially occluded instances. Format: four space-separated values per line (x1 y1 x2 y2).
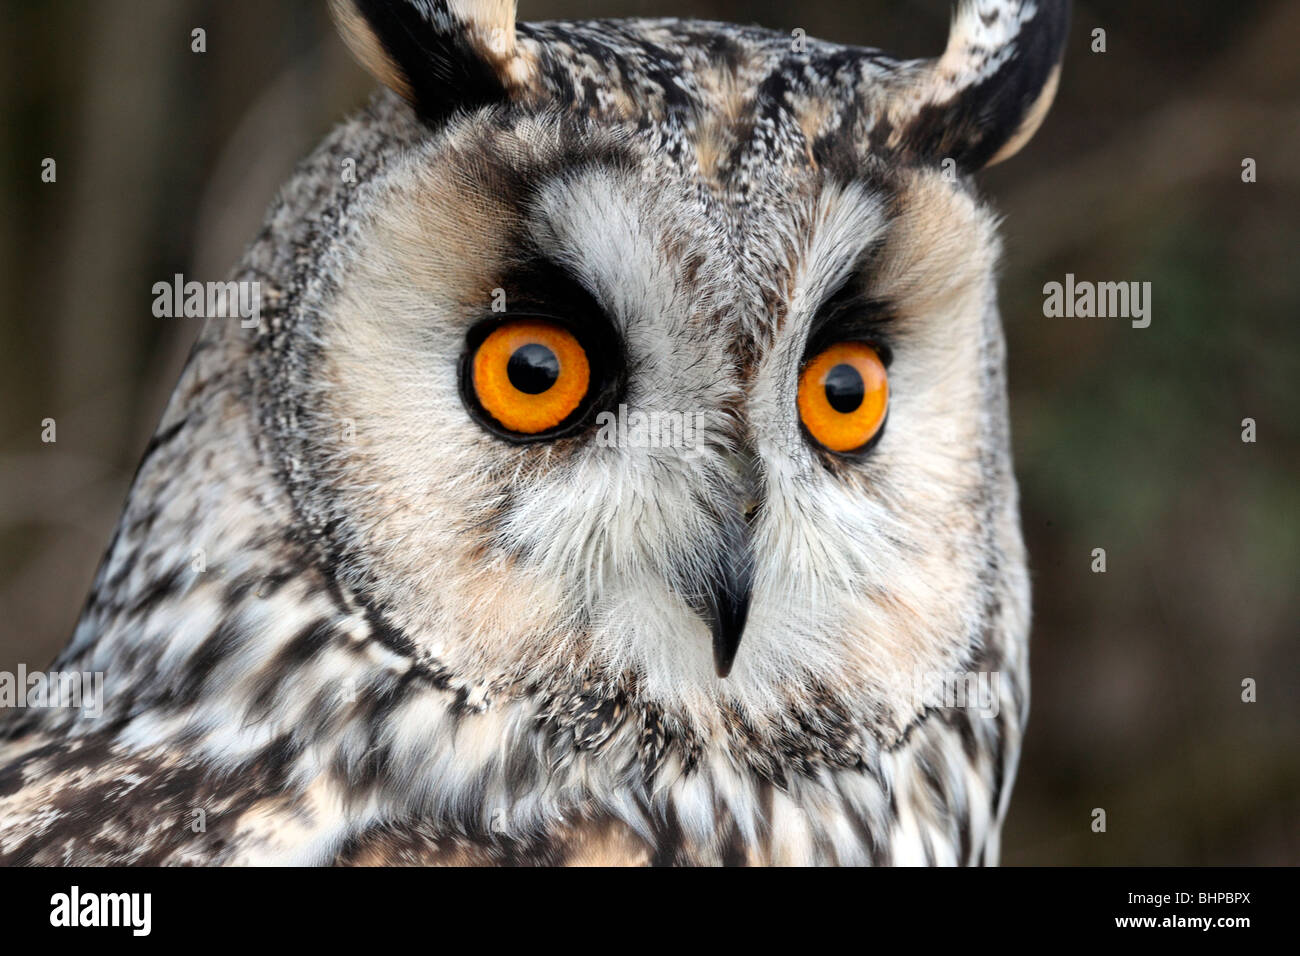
471 319 592 434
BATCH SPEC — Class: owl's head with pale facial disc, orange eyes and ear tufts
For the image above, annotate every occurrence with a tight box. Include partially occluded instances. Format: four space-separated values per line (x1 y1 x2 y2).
260 0 1067 736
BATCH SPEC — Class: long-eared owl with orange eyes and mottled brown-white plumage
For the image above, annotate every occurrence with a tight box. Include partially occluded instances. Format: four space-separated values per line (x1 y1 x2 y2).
0 0 1069 865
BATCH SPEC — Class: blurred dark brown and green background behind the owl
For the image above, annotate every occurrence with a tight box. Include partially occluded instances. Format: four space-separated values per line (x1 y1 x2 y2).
0 0 1300 865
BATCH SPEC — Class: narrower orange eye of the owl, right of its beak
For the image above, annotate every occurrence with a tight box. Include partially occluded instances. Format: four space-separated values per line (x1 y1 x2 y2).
798 342 889 453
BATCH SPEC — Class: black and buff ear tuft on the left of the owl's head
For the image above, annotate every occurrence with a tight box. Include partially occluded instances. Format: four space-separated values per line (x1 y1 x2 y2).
329 0 528 124
